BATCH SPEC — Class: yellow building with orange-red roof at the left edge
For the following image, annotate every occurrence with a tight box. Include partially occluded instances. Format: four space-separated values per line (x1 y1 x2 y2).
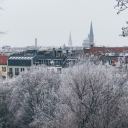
0 56 8 79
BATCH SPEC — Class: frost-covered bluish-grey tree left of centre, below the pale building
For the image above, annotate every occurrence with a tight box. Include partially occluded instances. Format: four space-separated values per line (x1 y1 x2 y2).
2 67 60 128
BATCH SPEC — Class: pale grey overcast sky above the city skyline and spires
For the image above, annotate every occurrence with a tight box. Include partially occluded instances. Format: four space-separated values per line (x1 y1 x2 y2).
0 0 128 47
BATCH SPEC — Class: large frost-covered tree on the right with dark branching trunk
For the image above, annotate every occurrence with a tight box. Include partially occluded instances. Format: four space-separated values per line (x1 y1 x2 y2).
61 62 127 128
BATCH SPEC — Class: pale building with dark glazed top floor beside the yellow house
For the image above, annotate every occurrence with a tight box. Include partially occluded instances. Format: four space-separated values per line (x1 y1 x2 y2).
7 50 37 78
